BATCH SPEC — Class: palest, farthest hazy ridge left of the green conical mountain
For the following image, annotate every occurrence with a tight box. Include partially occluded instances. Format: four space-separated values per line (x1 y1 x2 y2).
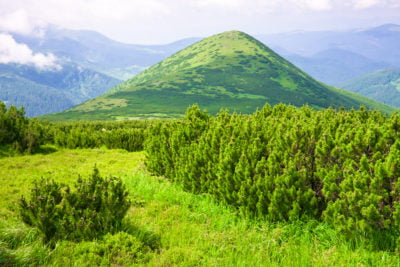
13 26 200 80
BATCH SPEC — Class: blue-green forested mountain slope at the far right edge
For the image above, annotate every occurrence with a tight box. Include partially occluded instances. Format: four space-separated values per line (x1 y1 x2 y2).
340 69 400 107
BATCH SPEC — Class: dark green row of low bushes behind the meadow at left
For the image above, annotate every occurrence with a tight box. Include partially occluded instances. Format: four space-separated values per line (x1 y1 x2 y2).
0 102 151 154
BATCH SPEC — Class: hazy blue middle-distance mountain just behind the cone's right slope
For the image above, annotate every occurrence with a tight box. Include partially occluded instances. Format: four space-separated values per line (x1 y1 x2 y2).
285 48 391 86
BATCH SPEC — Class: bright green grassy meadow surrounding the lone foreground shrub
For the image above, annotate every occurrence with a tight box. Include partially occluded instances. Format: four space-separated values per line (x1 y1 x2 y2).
0 149 399 266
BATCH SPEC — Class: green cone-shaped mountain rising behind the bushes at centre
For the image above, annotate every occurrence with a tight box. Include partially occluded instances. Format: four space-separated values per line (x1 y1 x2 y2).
45 31 391 119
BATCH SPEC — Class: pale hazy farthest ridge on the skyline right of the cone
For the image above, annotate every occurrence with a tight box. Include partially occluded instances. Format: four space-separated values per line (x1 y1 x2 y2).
258 24 400 67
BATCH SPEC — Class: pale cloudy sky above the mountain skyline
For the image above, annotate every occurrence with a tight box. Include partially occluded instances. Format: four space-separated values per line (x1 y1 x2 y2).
0 0 400 44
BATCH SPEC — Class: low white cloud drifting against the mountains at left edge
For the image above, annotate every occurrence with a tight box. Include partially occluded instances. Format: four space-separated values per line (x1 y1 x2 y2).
0 33 61 71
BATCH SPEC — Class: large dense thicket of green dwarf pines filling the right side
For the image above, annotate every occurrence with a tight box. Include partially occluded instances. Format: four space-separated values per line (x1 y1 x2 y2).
146 105 400 248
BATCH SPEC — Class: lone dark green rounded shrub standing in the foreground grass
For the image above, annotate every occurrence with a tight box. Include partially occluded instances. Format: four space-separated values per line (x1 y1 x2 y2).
19 168 130 246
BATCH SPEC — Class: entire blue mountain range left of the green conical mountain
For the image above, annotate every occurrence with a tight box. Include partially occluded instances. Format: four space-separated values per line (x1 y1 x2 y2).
0 26 198 117
